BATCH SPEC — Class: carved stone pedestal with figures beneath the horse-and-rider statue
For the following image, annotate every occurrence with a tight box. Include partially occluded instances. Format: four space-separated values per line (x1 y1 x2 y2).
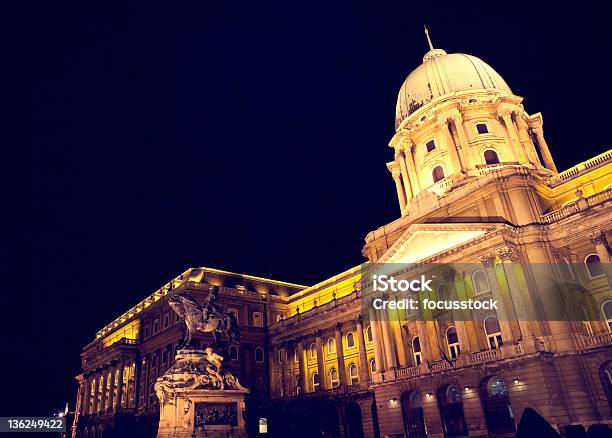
155 348 249 438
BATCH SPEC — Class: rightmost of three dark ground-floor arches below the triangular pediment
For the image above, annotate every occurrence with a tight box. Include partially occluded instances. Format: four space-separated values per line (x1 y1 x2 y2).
480 376 516 434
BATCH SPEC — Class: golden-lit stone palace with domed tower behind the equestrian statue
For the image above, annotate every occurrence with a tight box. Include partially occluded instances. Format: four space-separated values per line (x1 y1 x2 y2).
75 42 612 438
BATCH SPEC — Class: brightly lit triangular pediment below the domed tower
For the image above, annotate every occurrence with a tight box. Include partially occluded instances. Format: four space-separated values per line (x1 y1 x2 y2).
377 223 503 263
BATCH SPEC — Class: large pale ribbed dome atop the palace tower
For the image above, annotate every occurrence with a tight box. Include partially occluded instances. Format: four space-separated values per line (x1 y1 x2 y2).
395 49 512 128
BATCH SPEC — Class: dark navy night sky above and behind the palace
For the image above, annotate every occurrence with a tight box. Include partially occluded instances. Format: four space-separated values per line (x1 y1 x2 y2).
21 1 612 415
